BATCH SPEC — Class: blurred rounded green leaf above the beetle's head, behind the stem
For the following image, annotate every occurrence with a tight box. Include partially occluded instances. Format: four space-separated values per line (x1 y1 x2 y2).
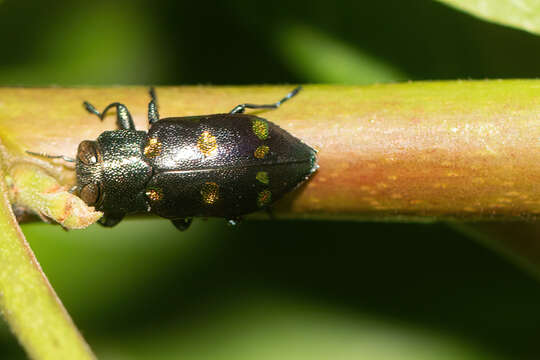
0 1 167 86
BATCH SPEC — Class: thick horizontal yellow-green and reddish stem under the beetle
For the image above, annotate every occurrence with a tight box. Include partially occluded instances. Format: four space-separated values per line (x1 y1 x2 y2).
0 80 540 221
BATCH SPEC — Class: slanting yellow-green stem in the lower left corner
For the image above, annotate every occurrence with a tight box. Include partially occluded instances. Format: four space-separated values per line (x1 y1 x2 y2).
0 164 95 360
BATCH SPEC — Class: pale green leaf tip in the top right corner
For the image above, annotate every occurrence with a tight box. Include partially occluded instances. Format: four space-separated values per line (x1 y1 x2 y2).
438 0 540 34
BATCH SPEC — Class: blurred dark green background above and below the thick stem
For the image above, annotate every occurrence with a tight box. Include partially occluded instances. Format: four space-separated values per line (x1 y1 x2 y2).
0 0 540 360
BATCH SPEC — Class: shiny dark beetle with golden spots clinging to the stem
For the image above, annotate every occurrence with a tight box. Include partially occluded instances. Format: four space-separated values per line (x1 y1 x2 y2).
29 87 318 230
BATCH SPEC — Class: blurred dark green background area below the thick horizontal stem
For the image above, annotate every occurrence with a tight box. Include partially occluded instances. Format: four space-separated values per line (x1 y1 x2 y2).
6 219 540 359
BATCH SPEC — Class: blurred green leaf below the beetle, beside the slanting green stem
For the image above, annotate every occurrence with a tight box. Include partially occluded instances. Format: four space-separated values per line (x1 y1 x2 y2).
16 219 225 318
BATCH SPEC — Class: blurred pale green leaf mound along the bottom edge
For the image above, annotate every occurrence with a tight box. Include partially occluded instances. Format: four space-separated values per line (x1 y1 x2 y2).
97 295 499 360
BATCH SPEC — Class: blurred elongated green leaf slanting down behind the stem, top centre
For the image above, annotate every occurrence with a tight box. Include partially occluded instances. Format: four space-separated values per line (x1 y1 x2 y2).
276 25 407 84
